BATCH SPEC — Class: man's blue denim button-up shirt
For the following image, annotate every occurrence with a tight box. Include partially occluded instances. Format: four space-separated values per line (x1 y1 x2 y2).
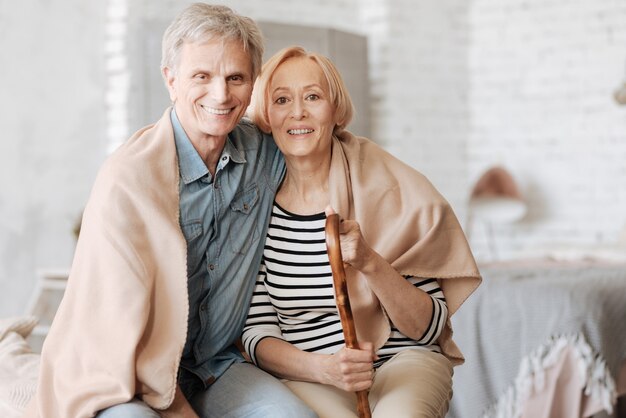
171 110 285 398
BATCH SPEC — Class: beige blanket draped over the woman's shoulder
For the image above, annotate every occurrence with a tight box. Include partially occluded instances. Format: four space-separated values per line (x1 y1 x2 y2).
329 131 481 364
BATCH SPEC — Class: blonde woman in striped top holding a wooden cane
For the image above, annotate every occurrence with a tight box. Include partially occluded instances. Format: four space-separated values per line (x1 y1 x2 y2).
243 47 480 418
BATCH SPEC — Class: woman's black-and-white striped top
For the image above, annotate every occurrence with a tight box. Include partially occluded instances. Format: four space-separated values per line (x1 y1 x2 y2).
242 203 448 367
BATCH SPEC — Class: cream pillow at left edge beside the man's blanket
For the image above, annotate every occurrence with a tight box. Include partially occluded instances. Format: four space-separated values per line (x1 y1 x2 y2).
0 316 39 418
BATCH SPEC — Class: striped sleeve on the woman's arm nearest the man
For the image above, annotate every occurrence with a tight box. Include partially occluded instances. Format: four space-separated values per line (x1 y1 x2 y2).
241 263 284 365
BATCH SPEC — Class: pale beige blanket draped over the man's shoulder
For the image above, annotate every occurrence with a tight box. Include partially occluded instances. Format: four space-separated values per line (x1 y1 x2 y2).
26 109 188 418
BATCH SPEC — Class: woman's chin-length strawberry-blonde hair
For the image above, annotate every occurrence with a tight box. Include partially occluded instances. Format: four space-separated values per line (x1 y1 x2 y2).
249 46 354 133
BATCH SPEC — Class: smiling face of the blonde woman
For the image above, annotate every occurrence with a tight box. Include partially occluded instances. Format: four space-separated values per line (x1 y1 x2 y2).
268 57 335 159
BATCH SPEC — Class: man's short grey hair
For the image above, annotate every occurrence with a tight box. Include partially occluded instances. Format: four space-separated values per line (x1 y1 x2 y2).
161 3 263 80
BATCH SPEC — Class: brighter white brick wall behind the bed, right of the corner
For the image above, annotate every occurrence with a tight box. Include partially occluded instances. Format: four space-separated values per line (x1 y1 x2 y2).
468 0 626 257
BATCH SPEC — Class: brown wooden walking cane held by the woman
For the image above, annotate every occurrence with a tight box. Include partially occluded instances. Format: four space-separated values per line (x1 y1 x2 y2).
326 213 372 418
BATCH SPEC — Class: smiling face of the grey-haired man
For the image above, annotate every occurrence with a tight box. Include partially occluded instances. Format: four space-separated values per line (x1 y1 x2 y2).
163 39 253 142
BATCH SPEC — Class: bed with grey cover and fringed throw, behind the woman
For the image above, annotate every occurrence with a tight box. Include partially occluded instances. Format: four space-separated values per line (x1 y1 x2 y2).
447 261 626 418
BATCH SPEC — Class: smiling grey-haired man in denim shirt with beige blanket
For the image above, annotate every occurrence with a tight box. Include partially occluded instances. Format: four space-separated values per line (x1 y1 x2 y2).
27 3 315 418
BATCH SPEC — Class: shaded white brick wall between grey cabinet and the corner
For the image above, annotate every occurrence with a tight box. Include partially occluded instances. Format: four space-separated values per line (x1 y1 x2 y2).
365 0 468 214
